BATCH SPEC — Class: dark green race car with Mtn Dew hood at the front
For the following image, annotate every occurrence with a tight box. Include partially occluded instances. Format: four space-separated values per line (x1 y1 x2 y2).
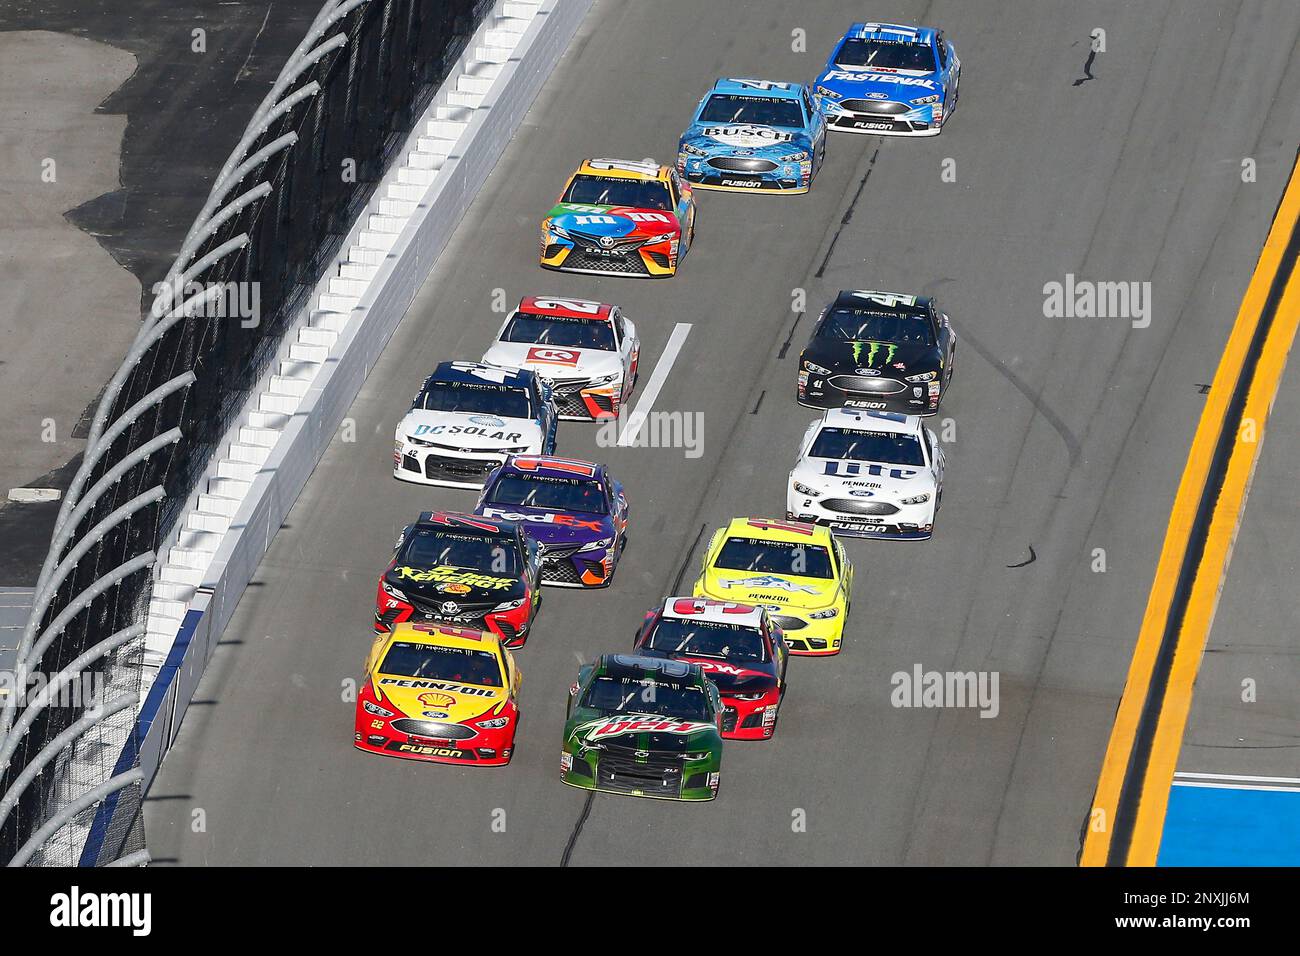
560 654 723 800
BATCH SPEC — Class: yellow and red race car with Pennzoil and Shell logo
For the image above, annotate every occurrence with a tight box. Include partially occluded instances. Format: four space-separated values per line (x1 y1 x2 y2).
356 624 520 766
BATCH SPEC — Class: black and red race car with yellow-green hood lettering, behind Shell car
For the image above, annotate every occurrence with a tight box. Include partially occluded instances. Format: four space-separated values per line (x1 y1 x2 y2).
374 511 542 648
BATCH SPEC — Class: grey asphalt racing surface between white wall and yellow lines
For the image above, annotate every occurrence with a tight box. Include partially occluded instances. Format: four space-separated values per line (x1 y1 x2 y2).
146 0 1300 865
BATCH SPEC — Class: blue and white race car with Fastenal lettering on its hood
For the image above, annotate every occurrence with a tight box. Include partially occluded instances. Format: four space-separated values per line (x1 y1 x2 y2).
815 23 962 137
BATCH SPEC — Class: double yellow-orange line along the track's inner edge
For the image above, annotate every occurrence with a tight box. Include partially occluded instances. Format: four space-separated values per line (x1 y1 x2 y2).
1079 151 1300 866
